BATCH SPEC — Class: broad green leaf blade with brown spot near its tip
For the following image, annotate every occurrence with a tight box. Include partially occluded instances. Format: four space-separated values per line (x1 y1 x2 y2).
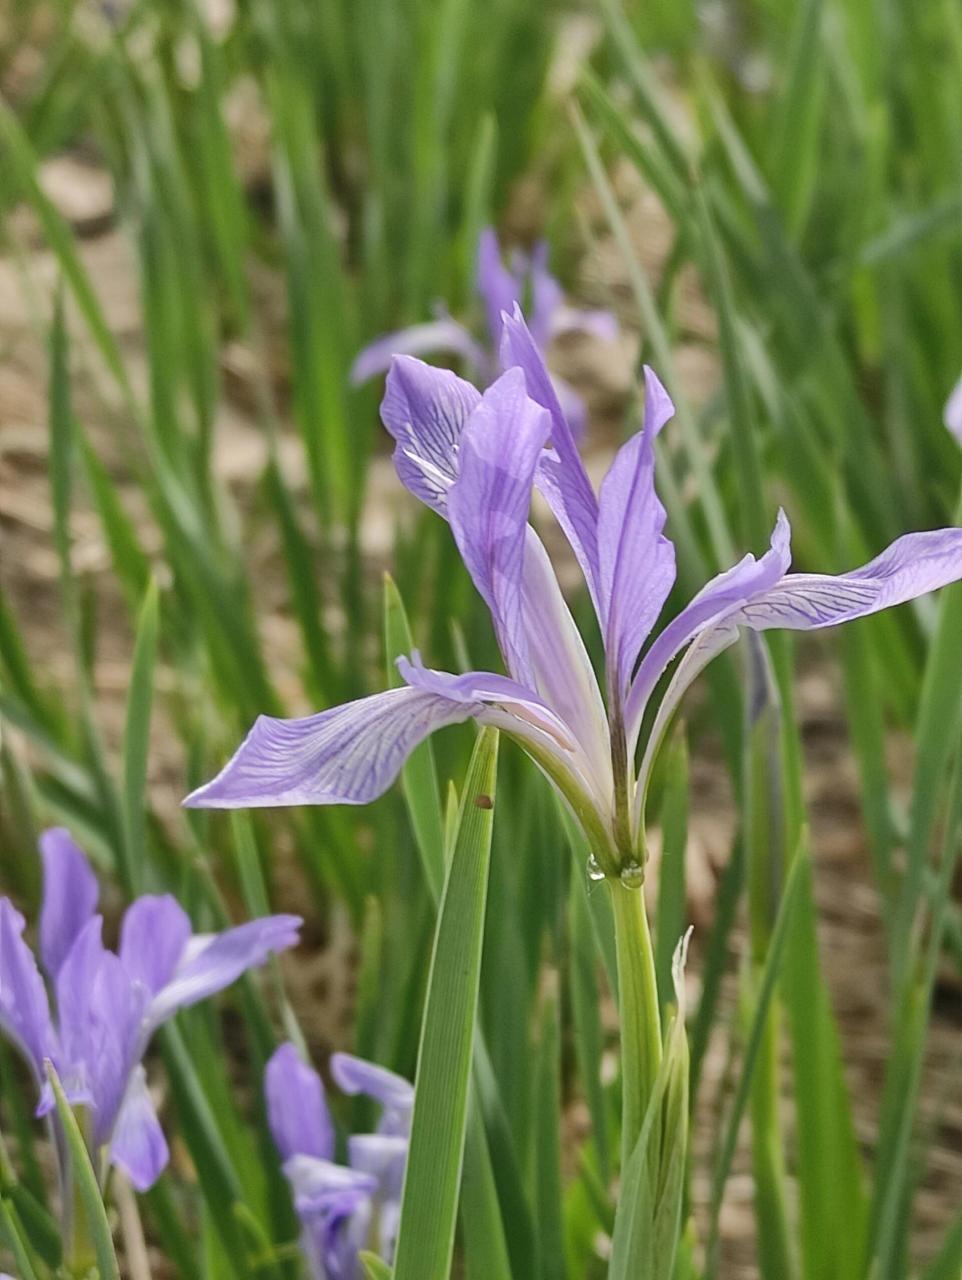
394 730 498 1280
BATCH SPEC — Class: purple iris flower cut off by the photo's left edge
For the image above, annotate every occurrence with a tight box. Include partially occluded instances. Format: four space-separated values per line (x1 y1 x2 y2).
0 828 301 1190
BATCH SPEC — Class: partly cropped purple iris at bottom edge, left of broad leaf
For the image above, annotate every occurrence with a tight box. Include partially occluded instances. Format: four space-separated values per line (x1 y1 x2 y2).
265 1044 414 1280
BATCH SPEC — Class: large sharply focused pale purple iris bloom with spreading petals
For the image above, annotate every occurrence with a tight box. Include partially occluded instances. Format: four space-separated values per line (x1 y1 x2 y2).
187 306 962 882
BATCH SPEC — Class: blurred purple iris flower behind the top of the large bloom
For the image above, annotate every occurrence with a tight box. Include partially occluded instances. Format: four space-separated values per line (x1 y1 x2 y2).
351 227 618 435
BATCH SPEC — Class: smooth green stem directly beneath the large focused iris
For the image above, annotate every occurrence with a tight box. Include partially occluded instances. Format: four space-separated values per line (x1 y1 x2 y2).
609 879 661 1170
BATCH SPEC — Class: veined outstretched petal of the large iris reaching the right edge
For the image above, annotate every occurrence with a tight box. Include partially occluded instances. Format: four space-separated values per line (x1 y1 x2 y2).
732 529 962 631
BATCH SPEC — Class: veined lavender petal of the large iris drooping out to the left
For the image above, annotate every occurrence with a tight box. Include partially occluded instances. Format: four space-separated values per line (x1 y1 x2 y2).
184 689 475 809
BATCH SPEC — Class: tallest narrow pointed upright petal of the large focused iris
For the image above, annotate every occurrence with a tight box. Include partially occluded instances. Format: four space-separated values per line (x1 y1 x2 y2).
501 307 599 609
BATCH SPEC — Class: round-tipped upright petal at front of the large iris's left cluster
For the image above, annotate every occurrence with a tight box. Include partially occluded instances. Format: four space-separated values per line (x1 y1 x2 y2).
448 369 550 685
